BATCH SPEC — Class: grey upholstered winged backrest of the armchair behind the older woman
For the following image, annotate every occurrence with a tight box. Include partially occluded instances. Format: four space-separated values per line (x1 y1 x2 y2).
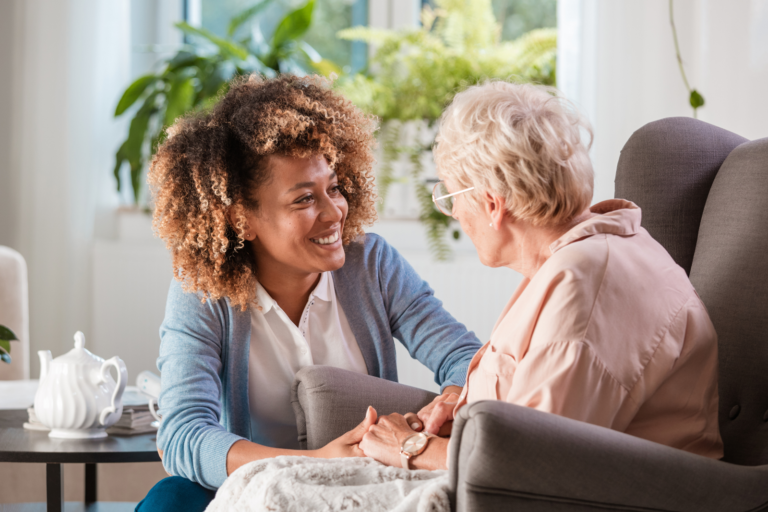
616 118 768 465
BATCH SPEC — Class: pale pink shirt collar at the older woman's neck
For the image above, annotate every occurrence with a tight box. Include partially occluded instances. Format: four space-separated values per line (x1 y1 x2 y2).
549 199 642 254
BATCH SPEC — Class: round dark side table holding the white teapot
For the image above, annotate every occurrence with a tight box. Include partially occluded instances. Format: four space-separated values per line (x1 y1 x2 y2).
0 409 160 512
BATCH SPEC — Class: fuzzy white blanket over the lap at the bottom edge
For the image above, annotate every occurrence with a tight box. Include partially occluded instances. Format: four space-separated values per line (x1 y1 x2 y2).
206 456 450 512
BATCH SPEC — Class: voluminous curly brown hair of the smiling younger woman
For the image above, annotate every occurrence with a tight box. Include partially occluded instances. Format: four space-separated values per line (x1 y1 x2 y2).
147 75 376 311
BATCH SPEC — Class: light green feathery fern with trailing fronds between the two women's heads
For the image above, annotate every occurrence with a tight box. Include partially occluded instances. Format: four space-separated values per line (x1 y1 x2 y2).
337 0 557 260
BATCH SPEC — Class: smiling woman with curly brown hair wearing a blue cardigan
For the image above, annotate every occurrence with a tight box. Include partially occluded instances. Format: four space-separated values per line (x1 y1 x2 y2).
138 75 481 511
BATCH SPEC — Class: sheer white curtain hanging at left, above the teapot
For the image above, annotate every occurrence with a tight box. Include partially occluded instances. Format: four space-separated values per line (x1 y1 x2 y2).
0 0 130 377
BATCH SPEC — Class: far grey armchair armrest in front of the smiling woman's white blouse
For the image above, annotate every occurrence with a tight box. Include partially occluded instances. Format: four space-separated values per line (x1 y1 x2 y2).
291 366 437 450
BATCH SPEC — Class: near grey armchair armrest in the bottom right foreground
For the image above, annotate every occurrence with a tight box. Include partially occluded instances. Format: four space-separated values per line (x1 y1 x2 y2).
448 402 768 512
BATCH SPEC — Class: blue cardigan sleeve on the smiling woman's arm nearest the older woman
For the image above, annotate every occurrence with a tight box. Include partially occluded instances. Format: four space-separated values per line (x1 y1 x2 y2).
376 235 482 390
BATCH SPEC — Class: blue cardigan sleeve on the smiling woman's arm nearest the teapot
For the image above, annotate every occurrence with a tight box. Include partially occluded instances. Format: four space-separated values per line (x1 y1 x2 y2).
157 280 243 489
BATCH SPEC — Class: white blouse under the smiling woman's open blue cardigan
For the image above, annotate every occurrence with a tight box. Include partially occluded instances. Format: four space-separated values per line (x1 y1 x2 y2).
248 272 368 449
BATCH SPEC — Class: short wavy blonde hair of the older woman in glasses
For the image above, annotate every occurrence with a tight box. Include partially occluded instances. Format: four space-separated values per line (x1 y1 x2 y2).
434 80 594 226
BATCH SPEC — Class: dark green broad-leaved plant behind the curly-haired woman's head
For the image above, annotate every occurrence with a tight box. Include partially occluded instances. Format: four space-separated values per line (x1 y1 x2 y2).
114 0 340 206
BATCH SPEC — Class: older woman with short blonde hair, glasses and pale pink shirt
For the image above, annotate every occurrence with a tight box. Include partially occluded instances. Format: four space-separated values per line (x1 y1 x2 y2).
360 82 723 469
